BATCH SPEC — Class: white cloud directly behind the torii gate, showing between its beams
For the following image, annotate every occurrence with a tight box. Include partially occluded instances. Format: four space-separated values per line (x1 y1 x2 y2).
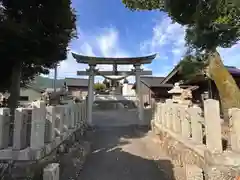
49 28 149 82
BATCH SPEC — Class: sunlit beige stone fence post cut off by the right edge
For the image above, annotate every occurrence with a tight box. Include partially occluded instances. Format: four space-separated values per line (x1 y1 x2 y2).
228 108 240 152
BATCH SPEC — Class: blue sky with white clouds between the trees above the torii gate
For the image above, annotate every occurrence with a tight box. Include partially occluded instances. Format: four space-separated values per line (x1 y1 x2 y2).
46 0 240 79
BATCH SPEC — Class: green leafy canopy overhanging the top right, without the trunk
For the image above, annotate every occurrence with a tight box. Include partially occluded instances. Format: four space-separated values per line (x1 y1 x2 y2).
122 0 240 51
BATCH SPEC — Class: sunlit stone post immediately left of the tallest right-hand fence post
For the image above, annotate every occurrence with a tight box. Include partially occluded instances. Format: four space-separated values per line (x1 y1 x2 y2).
188 107 203 144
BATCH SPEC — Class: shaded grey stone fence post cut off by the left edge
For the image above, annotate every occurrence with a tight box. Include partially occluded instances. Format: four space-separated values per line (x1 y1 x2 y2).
0 108 10 149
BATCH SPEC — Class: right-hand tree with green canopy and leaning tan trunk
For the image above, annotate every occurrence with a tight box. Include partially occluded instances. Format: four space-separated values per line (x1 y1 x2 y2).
122 0 240 112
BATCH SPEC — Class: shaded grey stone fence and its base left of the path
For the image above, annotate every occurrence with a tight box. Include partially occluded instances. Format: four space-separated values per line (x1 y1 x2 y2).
0 101 89 180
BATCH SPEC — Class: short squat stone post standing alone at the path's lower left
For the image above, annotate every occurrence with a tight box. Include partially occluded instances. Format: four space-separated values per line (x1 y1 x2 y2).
43 163 60 180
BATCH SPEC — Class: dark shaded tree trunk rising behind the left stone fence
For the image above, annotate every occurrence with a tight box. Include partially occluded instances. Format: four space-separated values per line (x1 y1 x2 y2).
8 63 22 145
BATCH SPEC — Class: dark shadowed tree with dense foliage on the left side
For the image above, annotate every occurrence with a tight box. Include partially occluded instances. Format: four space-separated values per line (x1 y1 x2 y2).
0 0 76 109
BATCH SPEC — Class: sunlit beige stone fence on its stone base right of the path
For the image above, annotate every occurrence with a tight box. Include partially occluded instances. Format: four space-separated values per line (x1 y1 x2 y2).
151 99 240 180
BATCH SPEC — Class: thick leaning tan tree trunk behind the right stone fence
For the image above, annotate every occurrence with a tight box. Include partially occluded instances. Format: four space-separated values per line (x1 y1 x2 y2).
208 51 240 119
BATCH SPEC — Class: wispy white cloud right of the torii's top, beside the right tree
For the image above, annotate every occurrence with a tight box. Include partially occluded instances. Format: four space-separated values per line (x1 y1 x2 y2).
140 17 186 64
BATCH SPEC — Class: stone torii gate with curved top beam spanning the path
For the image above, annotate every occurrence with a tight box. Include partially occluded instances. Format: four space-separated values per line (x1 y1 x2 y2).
72 53 156 125
